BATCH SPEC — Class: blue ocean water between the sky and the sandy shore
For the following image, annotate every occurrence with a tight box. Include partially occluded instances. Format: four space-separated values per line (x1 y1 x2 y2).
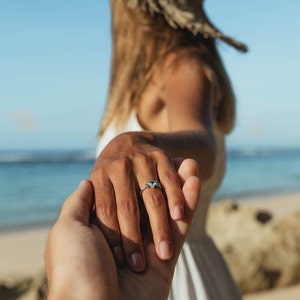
0 149 300 230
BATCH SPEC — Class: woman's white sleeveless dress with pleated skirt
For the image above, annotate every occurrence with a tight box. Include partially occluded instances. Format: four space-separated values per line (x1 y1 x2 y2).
97 112 241 300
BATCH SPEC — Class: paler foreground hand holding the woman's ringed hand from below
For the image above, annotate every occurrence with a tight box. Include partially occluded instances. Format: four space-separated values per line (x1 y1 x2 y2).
46 159 200 300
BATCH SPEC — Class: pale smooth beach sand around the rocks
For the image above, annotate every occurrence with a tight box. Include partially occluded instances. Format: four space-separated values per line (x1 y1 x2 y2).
0 193 300 300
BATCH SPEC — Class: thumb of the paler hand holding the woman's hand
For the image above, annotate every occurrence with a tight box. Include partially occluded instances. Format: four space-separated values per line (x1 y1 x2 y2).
59 180 94 225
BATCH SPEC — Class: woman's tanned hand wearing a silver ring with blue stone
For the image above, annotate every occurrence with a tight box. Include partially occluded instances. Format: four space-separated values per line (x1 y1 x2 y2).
90 132 192 272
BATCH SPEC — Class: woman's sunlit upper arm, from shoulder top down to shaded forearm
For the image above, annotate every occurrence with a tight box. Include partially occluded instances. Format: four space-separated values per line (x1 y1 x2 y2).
163 51 213 130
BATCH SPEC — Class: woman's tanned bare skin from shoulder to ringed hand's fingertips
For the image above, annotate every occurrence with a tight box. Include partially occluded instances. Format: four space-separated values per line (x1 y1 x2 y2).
90 54 216 272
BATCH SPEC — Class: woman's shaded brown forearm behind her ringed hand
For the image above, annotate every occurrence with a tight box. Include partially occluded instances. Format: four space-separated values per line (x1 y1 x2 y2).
153 131 217 181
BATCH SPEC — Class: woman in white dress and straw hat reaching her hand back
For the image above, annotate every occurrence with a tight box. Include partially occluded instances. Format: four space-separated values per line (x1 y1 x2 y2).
91 0 246 300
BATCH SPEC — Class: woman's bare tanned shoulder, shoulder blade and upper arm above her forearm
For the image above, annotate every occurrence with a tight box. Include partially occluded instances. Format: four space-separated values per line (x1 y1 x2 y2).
138 53 212 131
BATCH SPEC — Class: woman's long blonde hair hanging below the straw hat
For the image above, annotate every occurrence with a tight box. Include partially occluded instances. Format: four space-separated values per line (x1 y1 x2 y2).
99 0 235 136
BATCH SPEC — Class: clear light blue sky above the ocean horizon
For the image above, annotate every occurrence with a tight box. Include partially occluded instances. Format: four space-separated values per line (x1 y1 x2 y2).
0 0 300 150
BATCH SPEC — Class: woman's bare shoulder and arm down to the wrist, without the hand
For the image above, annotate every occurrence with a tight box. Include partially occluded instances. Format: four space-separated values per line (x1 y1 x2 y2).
137 54 216 181
